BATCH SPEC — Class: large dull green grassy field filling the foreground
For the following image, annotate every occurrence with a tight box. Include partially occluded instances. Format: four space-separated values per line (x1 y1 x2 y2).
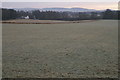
2 20 118 78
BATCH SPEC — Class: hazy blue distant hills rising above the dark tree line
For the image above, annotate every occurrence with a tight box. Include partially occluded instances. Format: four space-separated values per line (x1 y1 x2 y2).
14 8 97 12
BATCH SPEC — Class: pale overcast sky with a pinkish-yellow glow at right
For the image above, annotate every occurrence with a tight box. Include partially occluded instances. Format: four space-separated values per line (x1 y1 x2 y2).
2 2 118 10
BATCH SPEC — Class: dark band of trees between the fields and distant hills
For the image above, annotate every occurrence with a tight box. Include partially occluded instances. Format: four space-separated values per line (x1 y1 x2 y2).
2 8 120 20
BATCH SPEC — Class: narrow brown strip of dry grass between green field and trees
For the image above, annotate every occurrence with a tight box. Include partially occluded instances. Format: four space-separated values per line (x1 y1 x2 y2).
1 19 94 24
